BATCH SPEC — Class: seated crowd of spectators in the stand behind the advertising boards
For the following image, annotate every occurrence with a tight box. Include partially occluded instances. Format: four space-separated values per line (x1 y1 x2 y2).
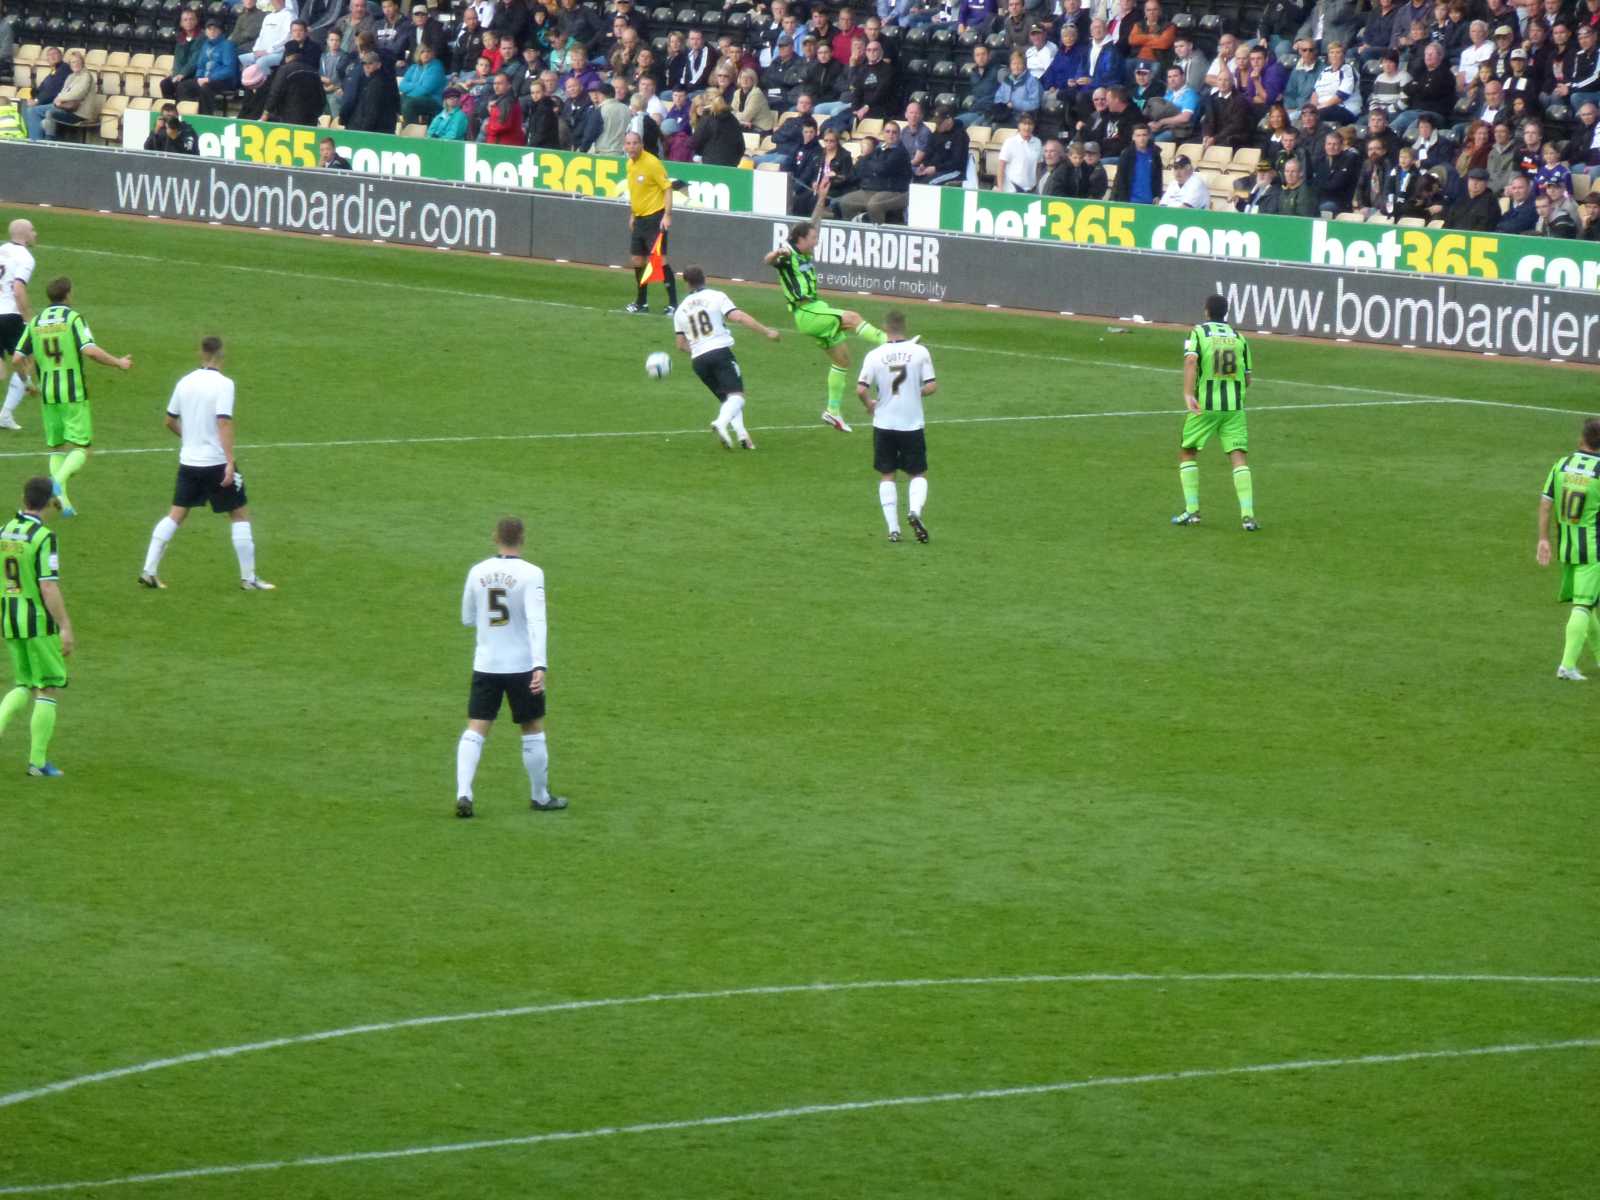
9 0 1600 240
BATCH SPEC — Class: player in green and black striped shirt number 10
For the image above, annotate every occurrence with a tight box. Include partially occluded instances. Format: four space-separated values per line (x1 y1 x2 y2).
1538 416 1600 680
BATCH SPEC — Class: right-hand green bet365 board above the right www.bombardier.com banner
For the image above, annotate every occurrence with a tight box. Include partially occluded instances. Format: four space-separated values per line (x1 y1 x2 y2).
909 184 1600 291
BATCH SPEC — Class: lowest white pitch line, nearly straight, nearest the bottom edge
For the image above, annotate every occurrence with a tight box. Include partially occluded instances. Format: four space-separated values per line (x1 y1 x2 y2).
0 1038 1600 1195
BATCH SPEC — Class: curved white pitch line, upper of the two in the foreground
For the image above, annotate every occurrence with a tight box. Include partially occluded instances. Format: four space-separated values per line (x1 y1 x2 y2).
0 971 1600 1109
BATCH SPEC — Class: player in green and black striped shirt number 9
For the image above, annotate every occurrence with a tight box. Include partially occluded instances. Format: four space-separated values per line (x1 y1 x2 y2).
0 475 72 779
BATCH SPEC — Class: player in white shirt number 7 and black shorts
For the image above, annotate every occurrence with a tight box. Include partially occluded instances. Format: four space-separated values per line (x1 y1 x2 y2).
856 312 939 542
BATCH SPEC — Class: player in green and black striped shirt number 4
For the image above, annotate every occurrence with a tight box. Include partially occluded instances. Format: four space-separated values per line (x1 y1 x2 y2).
11 275 133 517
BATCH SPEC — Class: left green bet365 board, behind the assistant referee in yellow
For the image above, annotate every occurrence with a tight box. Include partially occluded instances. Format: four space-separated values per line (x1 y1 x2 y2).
122 112 789 216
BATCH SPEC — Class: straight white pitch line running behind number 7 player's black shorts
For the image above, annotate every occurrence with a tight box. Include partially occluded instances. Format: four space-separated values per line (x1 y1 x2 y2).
0 400 1561 459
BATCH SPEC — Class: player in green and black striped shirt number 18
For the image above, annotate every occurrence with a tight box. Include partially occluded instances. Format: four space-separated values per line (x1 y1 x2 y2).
1173 296 1261 533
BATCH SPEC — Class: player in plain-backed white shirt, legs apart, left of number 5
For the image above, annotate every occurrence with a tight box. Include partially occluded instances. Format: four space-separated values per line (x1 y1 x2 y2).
139 338 274 592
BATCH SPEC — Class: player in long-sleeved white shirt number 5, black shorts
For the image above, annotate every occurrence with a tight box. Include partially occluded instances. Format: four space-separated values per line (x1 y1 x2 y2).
456 517 566 816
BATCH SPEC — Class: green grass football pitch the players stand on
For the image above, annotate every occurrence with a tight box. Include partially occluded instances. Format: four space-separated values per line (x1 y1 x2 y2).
0 208 1600 1200
